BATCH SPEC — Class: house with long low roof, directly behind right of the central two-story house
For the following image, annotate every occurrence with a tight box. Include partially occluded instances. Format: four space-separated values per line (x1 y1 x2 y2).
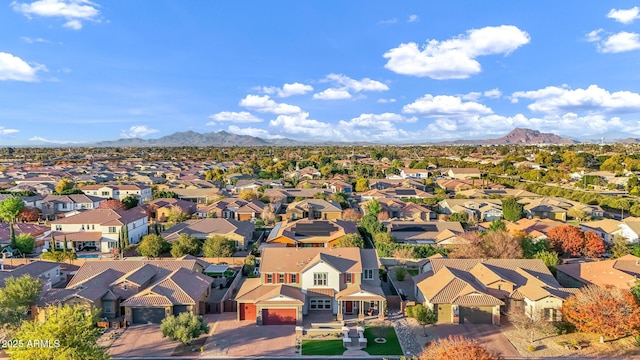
384 220 464 245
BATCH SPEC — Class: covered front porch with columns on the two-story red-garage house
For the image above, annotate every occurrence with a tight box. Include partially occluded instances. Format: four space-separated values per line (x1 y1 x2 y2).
336 284 387 321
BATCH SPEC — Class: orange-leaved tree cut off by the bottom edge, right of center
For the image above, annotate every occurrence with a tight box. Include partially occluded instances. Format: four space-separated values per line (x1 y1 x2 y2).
419 335 502 360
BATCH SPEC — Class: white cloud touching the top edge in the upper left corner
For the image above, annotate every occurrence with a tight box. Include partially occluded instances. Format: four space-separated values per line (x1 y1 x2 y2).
11 0 100 30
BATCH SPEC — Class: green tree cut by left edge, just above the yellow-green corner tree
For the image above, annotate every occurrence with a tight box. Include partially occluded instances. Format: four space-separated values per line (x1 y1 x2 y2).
0 275 42 327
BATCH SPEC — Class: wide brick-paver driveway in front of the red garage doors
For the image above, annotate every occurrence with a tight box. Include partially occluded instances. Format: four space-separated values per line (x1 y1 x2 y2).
202 312 299 358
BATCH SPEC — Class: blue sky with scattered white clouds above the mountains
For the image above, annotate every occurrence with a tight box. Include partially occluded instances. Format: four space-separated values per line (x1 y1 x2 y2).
0 0 640 145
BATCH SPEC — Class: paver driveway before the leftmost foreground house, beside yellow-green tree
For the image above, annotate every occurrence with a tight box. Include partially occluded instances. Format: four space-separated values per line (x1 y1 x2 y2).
103 324 180 358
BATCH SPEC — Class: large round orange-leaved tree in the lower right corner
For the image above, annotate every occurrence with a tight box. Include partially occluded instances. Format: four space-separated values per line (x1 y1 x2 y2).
562 285 640 342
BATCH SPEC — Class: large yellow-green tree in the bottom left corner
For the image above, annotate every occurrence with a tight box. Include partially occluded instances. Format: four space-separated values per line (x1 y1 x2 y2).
7 305 109 360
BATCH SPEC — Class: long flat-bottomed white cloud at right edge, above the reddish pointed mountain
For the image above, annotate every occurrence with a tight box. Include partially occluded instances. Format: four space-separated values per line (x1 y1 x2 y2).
511 85 640 114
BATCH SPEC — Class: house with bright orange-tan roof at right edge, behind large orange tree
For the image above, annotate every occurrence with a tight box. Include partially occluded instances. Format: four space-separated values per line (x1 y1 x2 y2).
556 255 640 289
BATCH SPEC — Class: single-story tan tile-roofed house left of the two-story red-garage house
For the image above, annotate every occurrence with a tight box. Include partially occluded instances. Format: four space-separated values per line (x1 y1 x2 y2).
36 260 213 324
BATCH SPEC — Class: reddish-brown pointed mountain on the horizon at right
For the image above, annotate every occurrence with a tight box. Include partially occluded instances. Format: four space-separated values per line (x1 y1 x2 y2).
434 128 578 145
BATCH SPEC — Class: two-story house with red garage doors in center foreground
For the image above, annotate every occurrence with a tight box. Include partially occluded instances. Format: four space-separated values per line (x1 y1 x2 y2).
235 247 386 325
